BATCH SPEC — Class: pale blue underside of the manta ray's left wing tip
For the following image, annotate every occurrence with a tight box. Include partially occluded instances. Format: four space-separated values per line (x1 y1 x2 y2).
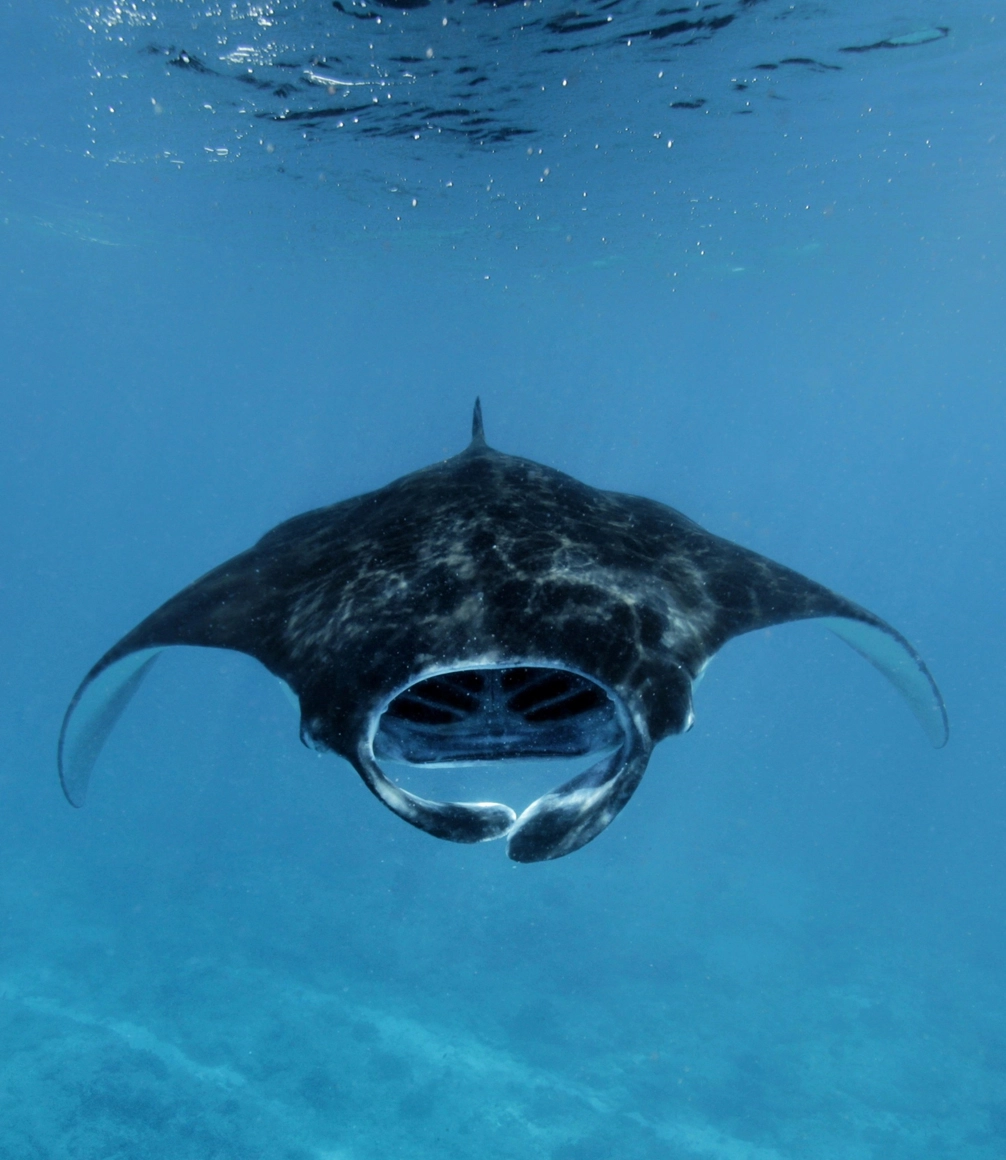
59 648 161 807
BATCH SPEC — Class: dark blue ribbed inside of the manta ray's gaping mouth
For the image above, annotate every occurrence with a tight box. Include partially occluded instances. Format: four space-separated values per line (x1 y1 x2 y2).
374 665 622 764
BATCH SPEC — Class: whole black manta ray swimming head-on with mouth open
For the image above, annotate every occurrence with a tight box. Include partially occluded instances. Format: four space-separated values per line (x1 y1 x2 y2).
59 401 948 862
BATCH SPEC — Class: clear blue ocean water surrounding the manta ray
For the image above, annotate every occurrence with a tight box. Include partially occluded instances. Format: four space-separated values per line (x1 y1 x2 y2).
0 0 1006 1160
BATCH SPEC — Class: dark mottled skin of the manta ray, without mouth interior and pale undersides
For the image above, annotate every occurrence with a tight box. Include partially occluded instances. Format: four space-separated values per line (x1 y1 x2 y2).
60 419 939 861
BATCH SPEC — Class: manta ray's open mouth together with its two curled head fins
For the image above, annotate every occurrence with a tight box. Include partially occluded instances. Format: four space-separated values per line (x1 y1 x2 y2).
354 665 651 862
